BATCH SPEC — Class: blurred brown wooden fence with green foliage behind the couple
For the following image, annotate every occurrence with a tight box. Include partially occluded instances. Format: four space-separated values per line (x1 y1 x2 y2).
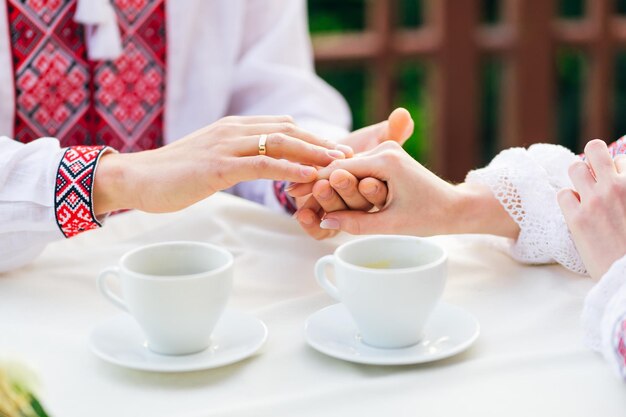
308 0 626 180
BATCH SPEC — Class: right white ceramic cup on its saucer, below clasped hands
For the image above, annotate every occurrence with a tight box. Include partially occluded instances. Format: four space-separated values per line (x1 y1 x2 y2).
315 235 447 348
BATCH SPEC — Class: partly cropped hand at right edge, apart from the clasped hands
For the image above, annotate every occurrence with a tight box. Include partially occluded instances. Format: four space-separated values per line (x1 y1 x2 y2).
557 139 626 280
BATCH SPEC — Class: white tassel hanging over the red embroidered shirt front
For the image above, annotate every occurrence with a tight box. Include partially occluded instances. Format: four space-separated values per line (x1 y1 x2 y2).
74 0 122 60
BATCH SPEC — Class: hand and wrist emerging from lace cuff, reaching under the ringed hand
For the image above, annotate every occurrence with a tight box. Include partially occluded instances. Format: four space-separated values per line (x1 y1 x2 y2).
298 141 519 238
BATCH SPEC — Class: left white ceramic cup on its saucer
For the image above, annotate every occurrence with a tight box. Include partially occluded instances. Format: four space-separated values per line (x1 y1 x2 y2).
98 242 234 355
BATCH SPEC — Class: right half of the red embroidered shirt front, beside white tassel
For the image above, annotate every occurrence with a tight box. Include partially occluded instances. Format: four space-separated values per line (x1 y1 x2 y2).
93 0 166 152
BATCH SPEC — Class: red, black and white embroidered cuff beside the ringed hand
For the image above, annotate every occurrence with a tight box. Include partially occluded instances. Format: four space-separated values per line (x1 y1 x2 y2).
54 146 112 238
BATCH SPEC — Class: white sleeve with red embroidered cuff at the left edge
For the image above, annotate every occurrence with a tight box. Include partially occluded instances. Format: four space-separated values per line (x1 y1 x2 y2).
0 137 109 272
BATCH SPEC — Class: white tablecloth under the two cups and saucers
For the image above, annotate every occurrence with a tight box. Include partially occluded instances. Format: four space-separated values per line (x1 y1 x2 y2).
0 195 626 417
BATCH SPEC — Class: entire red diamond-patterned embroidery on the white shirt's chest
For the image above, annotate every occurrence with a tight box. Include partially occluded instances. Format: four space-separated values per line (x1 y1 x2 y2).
7 0 166 151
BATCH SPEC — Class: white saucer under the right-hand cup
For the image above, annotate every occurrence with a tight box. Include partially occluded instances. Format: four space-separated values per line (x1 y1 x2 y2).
304 303 480 365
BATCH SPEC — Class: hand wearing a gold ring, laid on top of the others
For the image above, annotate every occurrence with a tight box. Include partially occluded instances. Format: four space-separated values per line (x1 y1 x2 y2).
94 116 352 215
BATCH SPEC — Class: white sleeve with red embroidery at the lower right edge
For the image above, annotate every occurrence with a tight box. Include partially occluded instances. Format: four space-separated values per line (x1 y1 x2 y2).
581 256 626 379
